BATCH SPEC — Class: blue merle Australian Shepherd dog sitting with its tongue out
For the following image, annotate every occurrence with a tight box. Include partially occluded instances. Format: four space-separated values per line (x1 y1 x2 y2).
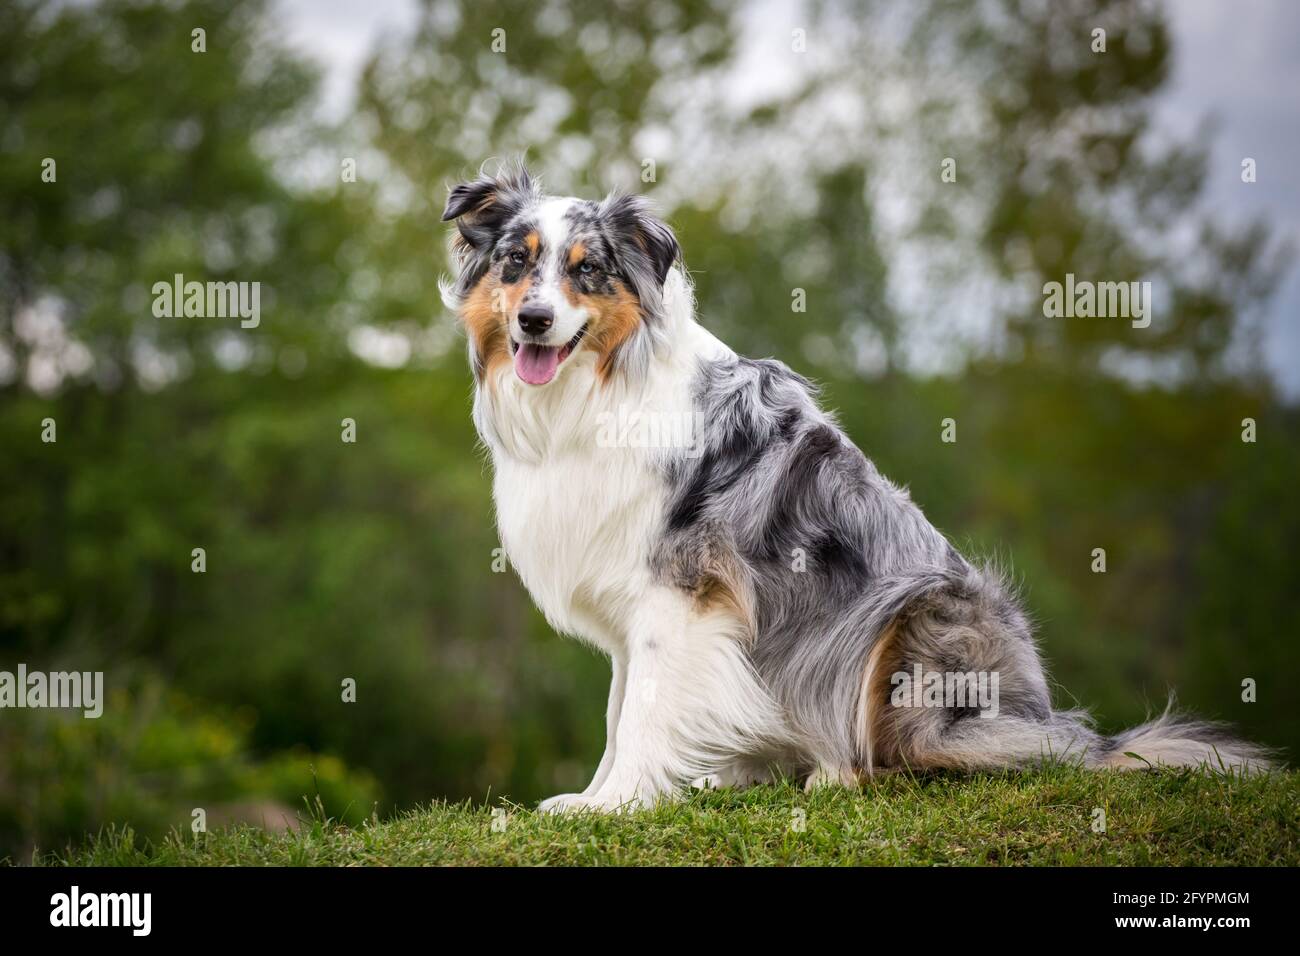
441 164 1270 812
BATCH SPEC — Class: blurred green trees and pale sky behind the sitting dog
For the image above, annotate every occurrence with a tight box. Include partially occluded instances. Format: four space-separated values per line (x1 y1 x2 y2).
0 0 1300 861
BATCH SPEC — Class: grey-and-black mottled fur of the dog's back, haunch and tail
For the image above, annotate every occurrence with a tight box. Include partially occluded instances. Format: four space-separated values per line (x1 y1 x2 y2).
653 358 1268 773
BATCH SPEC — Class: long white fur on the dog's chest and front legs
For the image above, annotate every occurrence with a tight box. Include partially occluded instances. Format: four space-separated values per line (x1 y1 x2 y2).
475 265 788 810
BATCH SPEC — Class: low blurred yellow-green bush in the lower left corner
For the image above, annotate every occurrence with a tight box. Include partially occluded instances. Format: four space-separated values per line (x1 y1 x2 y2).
0 679 378 861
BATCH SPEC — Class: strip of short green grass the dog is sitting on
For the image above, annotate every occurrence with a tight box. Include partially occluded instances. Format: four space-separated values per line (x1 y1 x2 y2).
39 766 1300 866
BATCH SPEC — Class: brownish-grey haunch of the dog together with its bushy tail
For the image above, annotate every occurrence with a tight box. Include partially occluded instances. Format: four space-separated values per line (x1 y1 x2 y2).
854 567 1277 775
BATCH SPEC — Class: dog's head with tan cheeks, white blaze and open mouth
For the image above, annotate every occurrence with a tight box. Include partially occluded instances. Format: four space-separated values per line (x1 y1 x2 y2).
442 165 681 386
